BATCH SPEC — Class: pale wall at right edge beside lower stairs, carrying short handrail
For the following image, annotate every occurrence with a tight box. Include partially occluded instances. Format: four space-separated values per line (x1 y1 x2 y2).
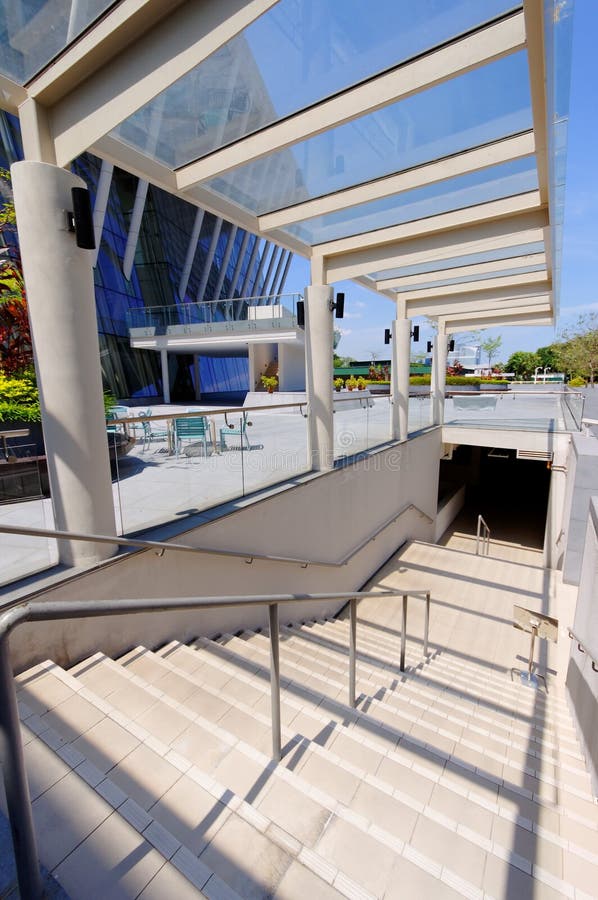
567 496 598 797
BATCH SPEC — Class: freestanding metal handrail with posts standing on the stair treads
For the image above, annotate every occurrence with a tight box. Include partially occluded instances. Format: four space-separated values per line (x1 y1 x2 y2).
0 589 430 900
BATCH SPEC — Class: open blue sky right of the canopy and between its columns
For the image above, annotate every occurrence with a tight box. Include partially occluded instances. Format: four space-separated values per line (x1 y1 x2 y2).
285 0 598 361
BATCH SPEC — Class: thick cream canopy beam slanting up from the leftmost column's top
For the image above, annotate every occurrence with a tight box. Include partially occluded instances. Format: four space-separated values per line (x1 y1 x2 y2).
42 0 278 166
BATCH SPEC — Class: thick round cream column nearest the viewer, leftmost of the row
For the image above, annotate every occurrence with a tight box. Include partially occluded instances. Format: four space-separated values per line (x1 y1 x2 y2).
11 161 117 565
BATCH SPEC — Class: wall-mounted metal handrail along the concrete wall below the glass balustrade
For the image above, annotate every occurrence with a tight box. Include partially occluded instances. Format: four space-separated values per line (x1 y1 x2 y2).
0 503 434 569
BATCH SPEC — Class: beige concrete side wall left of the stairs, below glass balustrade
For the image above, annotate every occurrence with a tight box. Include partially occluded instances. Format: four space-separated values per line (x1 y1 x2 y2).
11 429 441 670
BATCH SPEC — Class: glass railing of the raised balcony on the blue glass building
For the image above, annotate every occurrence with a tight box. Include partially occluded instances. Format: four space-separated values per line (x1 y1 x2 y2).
127 294 301 334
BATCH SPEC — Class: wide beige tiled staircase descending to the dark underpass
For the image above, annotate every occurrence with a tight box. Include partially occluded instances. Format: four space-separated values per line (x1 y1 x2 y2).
4 544 598 900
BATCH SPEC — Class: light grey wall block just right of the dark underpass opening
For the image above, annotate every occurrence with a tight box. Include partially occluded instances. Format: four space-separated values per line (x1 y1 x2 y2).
562 434 598 584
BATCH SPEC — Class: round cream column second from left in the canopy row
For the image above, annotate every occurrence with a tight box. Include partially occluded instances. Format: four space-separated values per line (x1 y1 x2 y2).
305 284 334 472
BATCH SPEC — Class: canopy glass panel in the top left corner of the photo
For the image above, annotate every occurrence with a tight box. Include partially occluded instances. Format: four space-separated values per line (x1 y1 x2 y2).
0 0 114 84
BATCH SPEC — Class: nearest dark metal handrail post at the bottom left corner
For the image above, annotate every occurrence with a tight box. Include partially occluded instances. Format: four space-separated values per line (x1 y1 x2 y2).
0 635 42 900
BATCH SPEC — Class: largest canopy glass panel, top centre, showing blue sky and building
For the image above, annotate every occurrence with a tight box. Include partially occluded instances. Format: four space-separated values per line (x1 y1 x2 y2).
111 0 520 167
